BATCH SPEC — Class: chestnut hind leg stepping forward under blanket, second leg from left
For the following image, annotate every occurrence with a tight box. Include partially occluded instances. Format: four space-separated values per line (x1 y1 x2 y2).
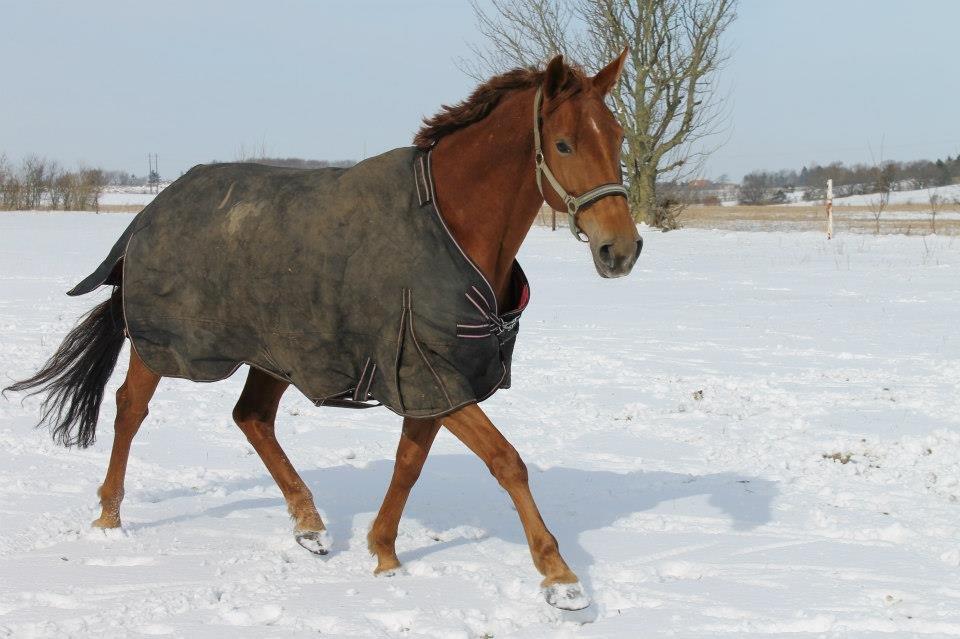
233 367 330 555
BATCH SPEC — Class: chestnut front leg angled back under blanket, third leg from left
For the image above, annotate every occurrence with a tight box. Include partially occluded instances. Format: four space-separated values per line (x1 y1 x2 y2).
367 417 440 574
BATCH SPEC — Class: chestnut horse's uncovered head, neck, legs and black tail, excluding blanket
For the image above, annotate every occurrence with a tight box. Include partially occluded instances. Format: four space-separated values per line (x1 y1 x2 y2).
10 51 642 609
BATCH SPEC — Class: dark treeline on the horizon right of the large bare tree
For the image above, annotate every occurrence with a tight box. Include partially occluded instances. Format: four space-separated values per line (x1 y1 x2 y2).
739 155 960 204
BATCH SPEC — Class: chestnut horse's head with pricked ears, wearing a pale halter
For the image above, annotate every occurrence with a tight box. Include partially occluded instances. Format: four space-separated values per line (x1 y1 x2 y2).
535 50 643 277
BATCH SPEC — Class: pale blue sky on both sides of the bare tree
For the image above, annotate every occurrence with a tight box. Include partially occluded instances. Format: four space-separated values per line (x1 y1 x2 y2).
0 0 960 179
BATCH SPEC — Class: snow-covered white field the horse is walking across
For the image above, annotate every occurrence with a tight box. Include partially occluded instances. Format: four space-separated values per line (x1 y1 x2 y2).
0 213 960 639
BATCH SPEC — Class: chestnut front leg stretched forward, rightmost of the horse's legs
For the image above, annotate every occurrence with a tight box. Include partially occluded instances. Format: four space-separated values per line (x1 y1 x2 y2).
443 404 590 610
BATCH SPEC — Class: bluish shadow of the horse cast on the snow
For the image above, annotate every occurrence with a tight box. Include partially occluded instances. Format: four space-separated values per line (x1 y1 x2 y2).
141 454 778 587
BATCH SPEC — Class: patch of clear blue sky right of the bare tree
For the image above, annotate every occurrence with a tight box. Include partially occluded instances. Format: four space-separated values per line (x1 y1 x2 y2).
707 0 960 178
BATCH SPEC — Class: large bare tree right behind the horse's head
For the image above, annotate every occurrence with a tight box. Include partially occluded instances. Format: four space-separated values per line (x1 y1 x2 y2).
461 0 736 228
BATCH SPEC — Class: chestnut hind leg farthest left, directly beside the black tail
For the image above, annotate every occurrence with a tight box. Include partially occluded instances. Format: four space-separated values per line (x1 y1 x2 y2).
93 348 160 528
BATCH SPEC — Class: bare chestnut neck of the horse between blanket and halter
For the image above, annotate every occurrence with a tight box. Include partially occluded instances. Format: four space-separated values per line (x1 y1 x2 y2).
431 90 543 303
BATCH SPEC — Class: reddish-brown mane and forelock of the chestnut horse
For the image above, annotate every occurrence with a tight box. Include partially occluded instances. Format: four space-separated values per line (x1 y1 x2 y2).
413 64 588 149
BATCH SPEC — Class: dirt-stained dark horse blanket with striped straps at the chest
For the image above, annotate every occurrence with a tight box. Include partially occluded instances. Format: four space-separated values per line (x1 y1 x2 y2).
68 148 529 417
